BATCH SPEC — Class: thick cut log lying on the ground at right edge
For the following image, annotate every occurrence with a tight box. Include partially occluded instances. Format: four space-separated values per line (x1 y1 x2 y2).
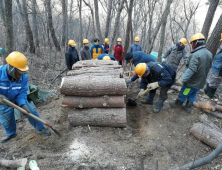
190 123 222 148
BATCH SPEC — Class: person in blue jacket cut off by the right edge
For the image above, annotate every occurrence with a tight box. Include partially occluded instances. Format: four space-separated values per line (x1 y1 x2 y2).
203 33 222 99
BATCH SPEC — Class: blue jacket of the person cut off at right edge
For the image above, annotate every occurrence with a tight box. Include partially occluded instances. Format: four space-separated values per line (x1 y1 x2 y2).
211 49 222 76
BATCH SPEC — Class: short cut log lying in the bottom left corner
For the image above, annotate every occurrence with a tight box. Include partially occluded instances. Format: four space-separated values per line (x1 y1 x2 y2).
0 158 27 168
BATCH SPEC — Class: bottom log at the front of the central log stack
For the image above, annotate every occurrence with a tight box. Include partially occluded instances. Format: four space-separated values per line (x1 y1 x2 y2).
68 108 126 127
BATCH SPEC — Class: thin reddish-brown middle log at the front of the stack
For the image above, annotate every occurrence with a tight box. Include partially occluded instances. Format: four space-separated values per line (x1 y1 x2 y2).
62 96 126 109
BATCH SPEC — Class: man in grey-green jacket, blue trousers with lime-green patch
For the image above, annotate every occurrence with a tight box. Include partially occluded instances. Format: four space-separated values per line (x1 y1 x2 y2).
170 33 212 113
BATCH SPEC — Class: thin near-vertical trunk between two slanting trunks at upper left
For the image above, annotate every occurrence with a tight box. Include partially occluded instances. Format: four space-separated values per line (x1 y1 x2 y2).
32 0 40 55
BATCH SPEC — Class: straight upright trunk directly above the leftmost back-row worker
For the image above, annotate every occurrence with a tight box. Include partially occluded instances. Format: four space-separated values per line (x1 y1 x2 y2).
61 0 67 47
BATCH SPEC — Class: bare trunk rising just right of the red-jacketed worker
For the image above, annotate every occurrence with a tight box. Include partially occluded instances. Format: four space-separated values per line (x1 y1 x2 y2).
124 0 134 53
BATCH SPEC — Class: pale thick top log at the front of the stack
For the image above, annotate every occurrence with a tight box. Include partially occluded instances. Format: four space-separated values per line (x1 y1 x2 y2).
60 76 127 97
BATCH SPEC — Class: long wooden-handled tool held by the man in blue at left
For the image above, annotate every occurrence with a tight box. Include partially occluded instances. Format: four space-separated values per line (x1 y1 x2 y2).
2 98 62 137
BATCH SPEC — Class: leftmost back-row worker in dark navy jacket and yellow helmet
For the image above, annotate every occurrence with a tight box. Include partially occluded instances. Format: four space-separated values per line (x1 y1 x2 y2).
65 40 79 70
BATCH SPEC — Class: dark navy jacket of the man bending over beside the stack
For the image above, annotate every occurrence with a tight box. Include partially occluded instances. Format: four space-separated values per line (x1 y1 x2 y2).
140 62 176 89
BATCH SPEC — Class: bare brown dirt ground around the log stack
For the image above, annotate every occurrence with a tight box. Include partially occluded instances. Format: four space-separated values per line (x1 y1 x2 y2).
0 54 222 170
